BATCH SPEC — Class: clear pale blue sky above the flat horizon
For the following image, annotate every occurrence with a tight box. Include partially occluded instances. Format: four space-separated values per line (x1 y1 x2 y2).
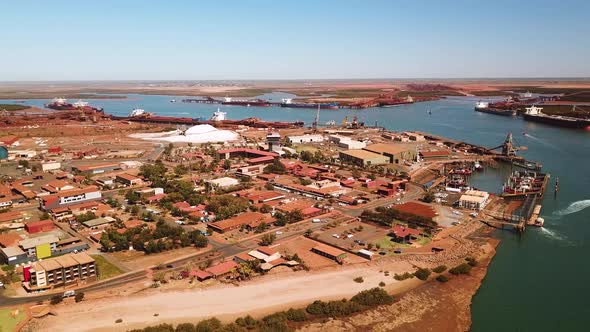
0 0 590 81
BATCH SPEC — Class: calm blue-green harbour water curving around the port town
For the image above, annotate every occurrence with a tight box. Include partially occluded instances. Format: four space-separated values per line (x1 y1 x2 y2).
13 94 590 331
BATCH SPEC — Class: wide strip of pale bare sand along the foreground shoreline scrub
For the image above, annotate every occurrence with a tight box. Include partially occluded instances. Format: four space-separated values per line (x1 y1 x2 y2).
35 263 412 331
